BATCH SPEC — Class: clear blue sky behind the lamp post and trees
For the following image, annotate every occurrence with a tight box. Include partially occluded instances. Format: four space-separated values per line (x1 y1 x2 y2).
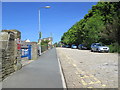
2 2 97 42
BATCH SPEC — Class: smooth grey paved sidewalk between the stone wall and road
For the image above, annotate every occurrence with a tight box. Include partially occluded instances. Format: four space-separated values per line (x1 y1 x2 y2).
2 48 63 88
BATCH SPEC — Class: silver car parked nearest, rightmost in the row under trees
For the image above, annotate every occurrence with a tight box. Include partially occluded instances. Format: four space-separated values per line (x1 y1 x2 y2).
91 43 109 53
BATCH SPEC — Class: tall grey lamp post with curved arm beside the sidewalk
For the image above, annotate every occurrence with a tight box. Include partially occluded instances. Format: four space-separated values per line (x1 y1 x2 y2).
38 6 50 55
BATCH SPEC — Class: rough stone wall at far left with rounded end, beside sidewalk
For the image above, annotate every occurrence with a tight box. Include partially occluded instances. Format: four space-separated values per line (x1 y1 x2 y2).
0 30 22 79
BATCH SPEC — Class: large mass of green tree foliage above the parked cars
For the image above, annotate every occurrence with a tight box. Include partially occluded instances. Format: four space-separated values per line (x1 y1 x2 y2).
61 2 120 50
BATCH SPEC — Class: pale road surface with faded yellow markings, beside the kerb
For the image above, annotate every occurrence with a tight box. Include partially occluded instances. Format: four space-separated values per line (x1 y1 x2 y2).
57 48 118 88
